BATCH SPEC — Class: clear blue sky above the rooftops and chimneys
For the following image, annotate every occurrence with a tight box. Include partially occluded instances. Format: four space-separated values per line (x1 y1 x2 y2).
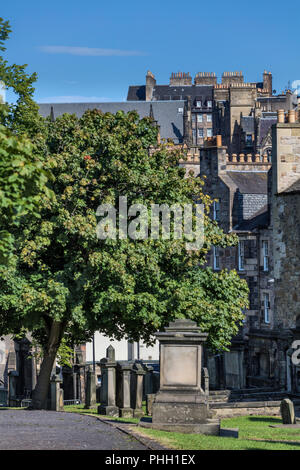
1 0 300 102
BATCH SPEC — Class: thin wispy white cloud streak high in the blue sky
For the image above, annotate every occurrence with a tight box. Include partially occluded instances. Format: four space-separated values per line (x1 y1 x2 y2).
39 46 143 57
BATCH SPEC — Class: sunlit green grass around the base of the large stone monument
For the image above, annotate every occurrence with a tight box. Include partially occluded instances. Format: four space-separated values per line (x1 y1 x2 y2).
65 405 300 450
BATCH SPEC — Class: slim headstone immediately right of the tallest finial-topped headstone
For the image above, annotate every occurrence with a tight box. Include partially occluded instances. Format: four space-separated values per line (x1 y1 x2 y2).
117 362 133 418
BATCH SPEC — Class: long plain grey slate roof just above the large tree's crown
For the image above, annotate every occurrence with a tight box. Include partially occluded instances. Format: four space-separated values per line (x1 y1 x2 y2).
39 101 184 143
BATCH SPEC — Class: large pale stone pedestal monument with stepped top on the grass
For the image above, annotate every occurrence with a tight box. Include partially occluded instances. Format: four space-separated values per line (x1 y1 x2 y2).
140 320 220 435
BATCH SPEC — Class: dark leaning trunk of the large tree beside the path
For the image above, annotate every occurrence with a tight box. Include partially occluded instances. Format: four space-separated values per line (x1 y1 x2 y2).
31 321 63 410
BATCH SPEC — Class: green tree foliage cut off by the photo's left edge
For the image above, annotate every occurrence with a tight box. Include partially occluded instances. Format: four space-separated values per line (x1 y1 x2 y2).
0 18 50 263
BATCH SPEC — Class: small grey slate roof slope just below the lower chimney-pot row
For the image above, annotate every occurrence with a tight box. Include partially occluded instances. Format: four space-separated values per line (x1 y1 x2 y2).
227 171 268 194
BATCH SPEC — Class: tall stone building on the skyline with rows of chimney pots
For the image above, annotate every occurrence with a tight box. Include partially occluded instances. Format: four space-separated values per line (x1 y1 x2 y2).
127 71 297 156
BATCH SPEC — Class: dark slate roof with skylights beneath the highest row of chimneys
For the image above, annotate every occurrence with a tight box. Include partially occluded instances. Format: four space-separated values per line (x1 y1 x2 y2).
127 85 214 106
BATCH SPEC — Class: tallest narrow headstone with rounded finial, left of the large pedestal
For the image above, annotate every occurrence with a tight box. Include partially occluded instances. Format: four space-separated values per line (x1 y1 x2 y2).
98 345 119 417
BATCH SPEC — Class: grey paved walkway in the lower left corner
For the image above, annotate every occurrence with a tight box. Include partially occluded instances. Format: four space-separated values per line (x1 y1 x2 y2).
0 409 147 450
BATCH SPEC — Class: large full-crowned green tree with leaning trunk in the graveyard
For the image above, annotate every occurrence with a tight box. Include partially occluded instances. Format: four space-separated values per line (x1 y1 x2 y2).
0 110 248 408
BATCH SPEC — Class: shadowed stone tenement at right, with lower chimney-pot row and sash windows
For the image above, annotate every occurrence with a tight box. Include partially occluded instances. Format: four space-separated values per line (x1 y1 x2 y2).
200 110 300 393
